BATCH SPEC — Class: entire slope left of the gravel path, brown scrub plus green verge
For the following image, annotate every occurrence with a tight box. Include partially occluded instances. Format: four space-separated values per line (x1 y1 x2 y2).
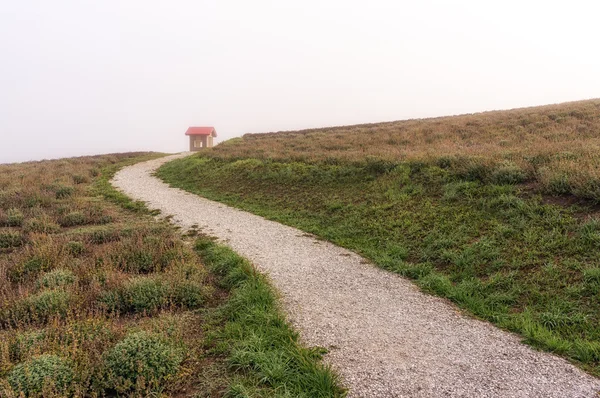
0 154 343 398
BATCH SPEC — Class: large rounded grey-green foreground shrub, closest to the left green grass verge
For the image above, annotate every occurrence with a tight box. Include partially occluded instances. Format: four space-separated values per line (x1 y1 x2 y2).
104 332 184 392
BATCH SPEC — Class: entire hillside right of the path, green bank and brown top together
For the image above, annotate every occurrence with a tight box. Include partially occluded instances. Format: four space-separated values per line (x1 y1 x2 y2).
158 100 600 375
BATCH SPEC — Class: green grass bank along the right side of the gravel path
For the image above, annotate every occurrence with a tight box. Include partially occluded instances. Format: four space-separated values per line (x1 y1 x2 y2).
158 154 600 375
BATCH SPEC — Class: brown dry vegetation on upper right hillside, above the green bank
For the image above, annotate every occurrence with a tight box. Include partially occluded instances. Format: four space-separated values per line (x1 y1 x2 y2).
208 99 600 201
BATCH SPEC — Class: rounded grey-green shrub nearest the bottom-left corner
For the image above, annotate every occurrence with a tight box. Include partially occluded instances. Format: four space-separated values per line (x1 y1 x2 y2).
8 354 73 396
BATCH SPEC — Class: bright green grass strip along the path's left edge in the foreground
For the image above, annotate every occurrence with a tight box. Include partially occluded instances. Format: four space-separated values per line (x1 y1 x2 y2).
195 237 345 398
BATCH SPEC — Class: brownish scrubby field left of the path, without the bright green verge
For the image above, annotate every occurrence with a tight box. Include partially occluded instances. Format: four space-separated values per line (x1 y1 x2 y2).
0 154 223 397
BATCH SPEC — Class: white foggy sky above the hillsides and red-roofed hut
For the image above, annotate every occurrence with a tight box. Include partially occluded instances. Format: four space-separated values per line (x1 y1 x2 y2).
0 0 600 163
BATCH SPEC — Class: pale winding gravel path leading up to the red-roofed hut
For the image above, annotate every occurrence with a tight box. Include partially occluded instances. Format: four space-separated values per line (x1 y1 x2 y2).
112 153 600 398
